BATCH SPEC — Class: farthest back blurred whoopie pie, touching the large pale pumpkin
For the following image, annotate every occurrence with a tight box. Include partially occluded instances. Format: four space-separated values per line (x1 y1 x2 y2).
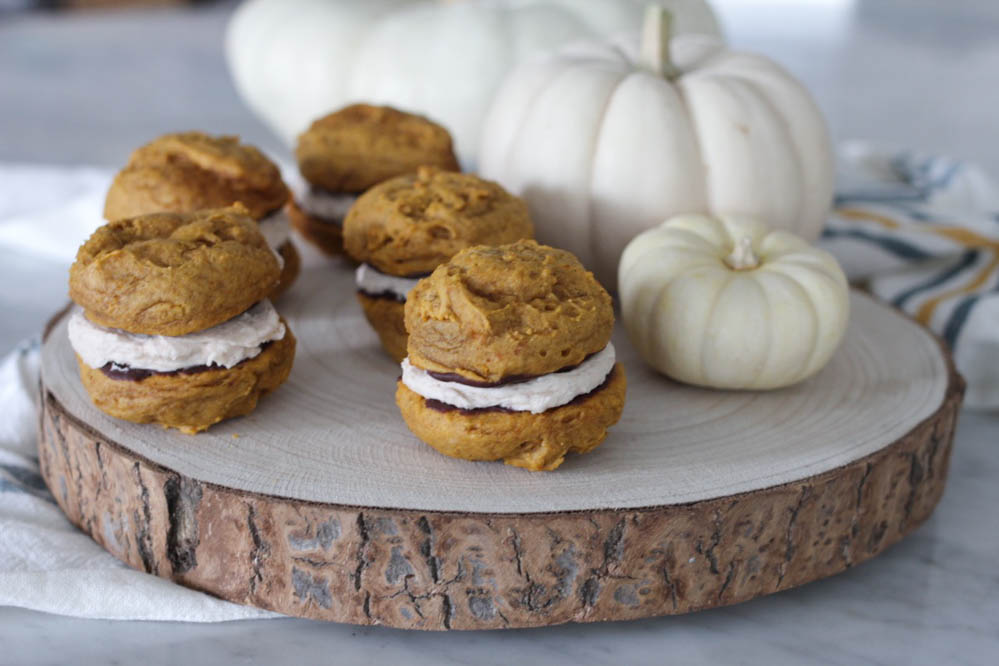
289 104 458 255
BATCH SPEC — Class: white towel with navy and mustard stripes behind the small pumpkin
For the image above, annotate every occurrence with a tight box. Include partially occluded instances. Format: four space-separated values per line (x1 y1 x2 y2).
821 145 999 409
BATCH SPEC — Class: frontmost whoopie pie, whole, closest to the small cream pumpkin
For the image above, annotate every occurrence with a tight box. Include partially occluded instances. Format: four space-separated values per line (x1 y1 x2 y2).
396 240 626 470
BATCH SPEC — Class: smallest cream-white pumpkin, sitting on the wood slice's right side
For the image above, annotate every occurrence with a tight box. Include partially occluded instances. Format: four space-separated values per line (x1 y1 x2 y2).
618 215 849 389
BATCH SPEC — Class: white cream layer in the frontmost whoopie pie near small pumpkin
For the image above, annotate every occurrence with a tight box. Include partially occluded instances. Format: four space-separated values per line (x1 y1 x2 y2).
402 342 615 414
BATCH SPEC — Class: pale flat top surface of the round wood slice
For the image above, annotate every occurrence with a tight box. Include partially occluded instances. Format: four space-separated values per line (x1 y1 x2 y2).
42 262 948 514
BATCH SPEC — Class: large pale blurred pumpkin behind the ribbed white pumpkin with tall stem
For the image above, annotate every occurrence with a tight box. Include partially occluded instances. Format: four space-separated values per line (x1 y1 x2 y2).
226 0 720 167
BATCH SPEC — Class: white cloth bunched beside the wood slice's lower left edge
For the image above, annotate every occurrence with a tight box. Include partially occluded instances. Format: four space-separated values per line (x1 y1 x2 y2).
0 341 278 622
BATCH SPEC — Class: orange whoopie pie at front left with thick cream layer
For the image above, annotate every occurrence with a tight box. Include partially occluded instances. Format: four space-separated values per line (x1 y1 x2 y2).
69 206 295 433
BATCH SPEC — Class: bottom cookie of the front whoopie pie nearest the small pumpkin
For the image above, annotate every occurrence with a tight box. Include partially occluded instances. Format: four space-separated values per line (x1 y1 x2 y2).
395 363 627 471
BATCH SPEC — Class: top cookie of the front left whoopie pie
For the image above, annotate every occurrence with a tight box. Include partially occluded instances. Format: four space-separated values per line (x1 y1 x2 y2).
69 206 281 335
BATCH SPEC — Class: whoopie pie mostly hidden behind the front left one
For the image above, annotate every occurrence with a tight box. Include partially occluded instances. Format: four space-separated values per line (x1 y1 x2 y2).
104 132 301 297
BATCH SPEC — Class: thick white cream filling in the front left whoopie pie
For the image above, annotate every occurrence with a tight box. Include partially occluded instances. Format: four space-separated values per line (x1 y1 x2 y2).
69 300 285 372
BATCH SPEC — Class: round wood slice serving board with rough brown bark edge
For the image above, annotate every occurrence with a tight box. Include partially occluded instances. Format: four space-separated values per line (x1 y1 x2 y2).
39 264 963 629
